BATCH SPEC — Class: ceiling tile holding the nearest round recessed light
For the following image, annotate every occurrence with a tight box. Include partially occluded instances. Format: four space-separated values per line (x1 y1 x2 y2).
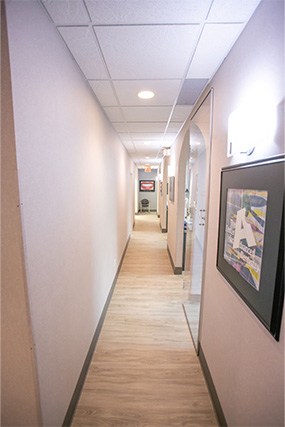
113 80 181 106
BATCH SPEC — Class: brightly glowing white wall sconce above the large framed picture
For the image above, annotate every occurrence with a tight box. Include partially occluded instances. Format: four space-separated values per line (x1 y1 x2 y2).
227 101 276 157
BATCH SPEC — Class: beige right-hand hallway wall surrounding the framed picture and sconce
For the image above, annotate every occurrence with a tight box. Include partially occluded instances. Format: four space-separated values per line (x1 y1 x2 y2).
168 0 284 426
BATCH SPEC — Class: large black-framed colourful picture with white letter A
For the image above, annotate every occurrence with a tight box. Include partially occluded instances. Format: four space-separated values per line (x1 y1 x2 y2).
217 155 284 341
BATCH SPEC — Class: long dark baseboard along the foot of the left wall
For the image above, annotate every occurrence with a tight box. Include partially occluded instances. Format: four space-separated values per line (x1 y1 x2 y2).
62 237 130 427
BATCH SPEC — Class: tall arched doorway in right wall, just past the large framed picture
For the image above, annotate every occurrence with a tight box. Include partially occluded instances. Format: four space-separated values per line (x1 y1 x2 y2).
183 91 212 351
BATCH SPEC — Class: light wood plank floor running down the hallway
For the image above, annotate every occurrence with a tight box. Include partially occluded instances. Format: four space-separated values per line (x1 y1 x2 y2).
72 214 218 427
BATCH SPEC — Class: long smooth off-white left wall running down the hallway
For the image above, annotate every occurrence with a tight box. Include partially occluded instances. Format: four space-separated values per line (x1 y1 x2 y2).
7 0 134 426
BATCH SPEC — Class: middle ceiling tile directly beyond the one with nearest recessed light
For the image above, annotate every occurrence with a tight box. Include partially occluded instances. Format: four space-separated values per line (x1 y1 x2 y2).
122 107 171 122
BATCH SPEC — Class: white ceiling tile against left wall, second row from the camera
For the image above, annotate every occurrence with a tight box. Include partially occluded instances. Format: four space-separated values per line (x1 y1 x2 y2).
58 27 108 80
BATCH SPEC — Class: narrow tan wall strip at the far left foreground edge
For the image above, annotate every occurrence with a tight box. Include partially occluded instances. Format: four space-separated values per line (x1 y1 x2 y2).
1 4 41 426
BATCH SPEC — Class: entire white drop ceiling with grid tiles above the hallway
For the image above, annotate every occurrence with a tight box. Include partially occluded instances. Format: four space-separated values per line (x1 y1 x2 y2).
41 0 260 166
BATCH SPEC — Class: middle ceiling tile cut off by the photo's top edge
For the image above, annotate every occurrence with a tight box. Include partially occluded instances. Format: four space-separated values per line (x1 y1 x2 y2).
85 0 211 25
